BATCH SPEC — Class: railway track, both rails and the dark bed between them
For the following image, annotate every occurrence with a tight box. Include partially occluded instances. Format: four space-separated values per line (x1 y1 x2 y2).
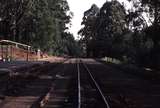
77 60 110 108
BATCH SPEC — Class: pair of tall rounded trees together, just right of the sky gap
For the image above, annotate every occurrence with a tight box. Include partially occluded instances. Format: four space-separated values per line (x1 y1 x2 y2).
79 1 126 56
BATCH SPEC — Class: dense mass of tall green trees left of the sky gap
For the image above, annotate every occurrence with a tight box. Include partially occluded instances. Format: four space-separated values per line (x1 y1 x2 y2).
0 0 76 55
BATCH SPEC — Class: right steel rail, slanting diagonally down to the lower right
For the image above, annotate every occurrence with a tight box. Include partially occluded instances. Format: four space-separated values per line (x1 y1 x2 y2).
80 60 110 108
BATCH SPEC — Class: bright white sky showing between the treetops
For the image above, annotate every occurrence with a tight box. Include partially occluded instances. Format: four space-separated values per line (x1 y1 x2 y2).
67 0 131 39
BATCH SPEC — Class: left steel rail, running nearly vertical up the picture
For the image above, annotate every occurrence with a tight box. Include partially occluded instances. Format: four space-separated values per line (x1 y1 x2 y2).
77 60 81 108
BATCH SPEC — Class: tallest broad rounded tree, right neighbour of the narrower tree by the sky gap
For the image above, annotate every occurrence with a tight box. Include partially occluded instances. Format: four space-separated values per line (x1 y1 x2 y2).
96 1 126 56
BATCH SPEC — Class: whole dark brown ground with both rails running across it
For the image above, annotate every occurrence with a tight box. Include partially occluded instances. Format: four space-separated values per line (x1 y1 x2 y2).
0 59 160 108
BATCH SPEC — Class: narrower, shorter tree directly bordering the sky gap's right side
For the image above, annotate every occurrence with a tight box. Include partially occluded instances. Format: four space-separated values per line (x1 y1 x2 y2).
78 4 99 57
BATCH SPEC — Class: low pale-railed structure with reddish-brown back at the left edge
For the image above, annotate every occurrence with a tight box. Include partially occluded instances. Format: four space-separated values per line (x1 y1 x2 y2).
0 40 37 61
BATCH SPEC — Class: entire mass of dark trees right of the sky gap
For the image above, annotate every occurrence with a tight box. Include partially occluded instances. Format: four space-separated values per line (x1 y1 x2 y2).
79 0 160 67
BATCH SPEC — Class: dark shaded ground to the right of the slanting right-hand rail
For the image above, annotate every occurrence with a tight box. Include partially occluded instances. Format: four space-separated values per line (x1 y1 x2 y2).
83 59 160 108
